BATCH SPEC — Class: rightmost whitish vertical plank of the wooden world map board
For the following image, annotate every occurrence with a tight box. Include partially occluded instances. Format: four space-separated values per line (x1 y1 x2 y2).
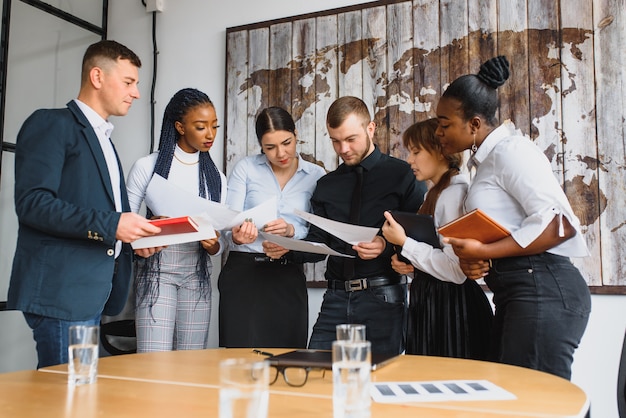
593 0 626 286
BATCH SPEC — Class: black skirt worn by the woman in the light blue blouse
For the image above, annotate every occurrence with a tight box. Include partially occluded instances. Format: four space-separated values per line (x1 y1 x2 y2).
218 251 309 348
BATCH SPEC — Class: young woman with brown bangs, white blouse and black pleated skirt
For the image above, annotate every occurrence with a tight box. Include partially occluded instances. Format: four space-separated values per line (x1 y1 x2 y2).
383 118 493 360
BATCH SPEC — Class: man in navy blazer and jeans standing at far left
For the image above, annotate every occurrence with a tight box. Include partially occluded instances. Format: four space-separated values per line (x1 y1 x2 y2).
8 41 160 367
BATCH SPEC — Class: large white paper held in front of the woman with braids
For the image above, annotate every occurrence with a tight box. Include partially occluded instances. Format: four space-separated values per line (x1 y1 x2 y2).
144 174 278 231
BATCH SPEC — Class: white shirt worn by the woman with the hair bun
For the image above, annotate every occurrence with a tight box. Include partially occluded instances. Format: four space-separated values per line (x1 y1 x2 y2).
465 122 589 257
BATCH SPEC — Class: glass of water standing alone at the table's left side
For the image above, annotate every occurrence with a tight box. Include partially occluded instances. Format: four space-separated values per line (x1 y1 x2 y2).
68 325 100 386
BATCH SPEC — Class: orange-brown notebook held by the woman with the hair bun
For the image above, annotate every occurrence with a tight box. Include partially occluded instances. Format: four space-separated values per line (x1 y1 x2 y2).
438 209 511 244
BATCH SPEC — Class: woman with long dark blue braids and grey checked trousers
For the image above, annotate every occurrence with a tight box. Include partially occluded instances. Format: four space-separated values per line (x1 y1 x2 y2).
127 88 226 352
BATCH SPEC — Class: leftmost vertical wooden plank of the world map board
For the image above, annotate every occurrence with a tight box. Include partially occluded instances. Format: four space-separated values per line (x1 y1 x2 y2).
224 31 248 175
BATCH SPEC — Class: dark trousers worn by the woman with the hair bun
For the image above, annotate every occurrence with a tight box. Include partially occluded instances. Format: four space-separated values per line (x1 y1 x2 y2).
485 253 591 379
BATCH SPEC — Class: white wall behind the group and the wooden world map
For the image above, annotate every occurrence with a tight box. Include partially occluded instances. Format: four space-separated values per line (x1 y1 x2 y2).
0 0 626 418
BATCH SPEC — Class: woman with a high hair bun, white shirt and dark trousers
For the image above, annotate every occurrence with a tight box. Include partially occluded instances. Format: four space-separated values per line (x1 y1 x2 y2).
437 56 591 379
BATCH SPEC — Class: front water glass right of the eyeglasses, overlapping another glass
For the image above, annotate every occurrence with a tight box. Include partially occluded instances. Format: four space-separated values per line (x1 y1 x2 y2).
333 340 372 418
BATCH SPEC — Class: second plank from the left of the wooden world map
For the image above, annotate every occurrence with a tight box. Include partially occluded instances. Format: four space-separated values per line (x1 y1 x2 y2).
241 28 270 155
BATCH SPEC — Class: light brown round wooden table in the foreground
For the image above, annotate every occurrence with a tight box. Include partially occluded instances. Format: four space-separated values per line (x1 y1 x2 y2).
0 349 588 418
